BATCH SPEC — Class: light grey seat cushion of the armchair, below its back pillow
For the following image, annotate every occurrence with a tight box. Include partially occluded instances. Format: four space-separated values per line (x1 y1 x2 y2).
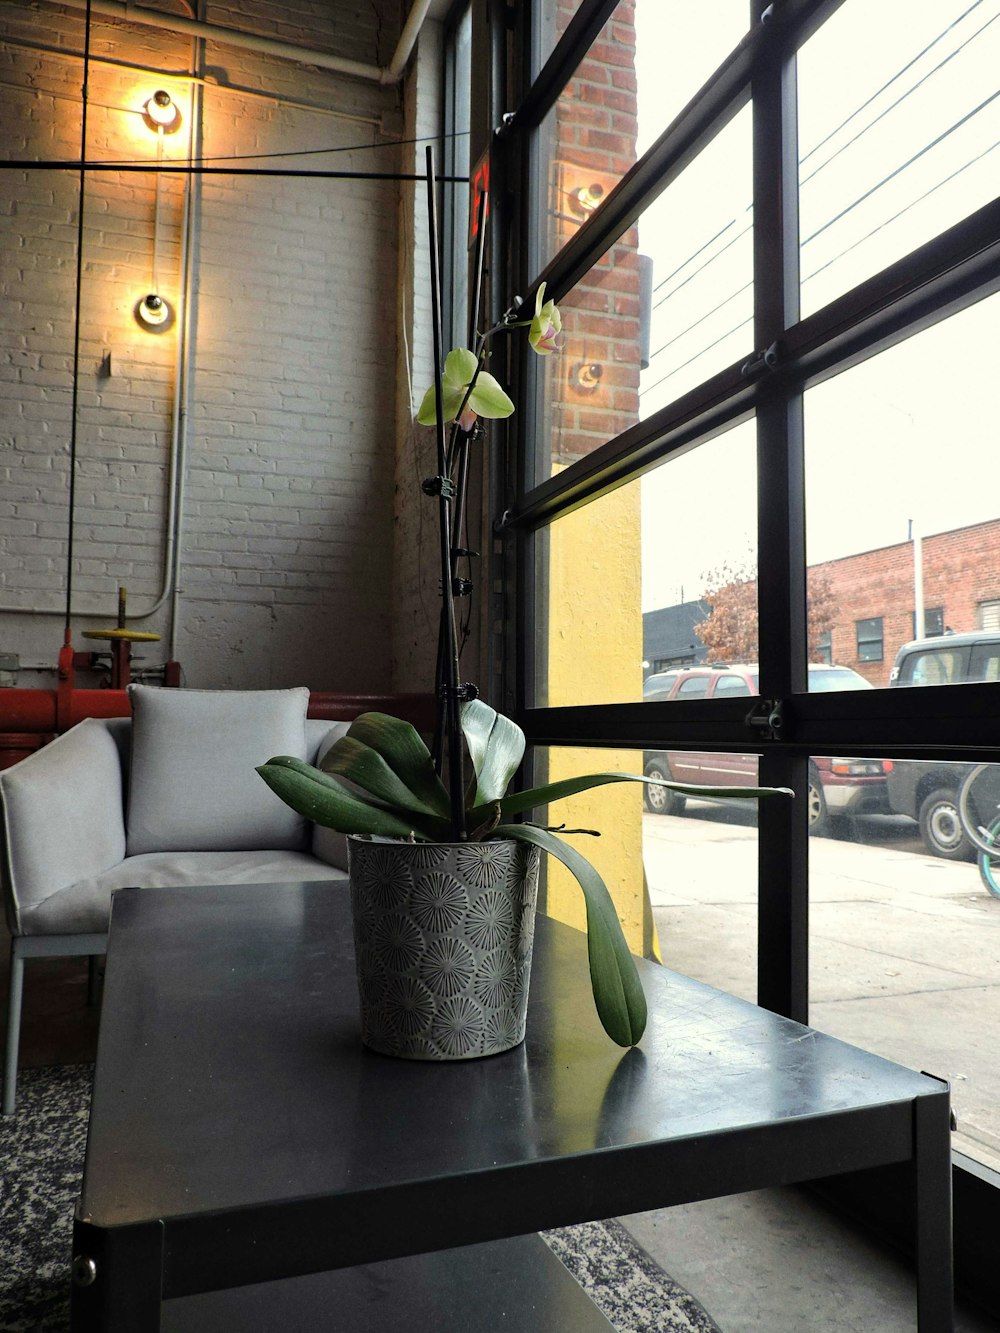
21 850 348 934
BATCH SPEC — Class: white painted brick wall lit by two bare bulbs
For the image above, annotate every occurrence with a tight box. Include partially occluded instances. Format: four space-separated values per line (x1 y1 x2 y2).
0 0 423 689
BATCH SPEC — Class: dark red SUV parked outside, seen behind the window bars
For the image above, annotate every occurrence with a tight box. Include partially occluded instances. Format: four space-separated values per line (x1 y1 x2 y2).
643 664 892 833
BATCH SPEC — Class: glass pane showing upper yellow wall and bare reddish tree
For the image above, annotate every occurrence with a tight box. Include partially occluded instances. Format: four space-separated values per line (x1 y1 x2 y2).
535 423 757 706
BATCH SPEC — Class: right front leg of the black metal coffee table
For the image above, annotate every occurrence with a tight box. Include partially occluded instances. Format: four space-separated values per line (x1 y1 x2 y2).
913 1092 955 1333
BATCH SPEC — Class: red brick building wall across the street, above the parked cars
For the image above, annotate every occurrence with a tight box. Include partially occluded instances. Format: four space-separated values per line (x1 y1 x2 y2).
811 519 1000 685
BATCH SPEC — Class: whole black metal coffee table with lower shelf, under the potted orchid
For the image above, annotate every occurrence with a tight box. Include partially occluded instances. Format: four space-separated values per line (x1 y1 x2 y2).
71 884 952 1333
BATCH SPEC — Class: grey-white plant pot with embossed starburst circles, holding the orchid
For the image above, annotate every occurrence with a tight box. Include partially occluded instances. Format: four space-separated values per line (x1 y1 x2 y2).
348 837 540 1060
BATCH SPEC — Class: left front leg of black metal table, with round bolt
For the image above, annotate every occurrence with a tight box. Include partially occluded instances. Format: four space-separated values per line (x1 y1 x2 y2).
69 1221 163 1333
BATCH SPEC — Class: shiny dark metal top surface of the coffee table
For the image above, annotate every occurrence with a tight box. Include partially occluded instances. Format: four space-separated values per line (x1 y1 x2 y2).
79 882 941 1226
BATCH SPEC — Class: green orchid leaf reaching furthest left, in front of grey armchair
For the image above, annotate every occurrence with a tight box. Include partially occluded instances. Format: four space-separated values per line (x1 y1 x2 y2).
257 754 448 841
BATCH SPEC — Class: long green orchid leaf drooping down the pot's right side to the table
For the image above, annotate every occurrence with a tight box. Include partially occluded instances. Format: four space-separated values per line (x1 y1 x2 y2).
493 824 647 1046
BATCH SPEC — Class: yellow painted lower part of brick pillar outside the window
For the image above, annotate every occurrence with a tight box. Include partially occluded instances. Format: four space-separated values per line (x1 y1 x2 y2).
548 485 656 954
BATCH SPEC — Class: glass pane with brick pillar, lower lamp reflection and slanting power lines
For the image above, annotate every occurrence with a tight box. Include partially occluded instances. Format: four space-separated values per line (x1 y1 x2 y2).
540 108 753 467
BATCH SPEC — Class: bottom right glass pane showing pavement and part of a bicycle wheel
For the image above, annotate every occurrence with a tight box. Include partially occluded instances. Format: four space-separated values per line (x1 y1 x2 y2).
809 758 1000 1168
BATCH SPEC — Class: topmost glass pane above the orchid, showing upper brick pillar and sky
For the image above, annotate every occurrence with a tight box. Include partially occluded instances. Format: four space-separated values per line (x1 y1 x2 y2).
539 0 749 268
